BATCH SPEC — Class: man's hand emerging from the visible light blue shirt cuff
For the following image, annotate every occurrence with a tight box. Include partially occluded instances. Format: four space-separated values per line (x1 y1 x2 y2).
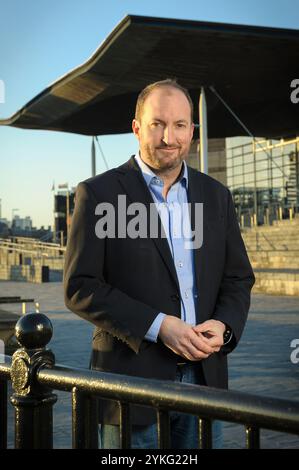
159 315 220 361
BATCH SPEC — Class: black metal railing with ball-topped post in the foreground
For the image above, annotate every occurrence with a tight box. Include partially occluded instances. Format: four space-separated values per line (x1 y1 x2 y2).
0 313 299 449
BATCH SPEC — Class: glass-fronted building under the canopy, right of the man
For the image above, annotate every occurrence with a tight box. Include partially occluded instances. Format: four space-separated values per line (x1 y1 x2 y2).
187 137 299 225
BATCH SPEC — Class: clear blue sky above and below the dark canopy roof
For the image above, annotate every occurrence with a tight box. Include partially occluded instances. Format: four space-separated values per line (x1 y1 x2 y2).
0 0 299 226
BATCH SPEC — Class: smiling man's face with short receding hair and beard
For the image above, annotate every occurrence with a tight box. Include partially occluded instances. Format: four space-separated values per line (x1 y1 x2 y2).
132 87 194 171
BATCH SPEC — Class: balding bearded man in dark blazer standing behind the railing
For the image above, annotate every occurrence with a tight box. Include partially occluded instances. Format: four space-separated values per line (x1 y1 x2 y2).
64 80 254 448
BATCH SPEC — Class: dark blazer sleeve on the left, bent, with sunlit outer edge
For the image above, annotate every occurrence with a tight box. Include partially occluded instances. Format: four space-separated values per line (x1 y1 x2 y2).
64 182 159 353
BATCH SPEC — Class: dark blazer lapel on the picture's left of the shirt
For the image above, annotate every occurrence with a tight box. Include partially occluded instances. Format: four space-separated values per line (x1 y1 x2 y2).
119 157 180 292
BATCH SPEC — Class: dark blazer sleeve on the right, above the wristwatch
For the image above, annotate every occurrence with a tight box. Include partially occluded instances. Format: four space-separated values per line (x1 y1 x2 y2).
213 190 255 353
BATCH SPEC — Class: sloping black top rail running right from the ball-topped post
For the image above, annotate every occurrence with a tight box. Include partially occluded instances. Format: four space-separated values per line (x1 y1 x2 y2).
37 365 299 434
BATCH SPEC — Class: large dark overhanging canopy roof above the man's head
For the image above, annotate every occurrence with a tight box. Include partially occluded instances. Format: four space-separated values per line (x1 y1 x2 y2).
0 15 299 138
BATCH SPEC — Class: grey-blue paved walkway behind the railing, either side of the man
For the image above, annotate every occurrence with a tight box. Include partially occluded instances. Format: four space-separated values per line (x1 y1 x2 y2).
0 281 299 448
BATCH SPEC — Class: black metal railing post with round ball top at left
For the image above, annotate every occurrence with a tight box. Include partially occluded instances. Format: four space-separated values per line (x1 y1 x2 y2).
10 313 57 449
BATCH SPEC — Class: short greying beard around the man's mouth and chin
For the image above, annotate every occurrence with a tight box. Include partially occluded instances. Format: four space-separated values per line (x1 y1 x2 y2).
140 143 191 172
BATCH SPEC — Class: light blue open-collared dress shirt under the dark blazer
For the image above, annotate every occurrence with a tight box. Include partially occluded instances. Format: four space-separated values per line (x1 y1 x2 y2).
135 154 197 342
